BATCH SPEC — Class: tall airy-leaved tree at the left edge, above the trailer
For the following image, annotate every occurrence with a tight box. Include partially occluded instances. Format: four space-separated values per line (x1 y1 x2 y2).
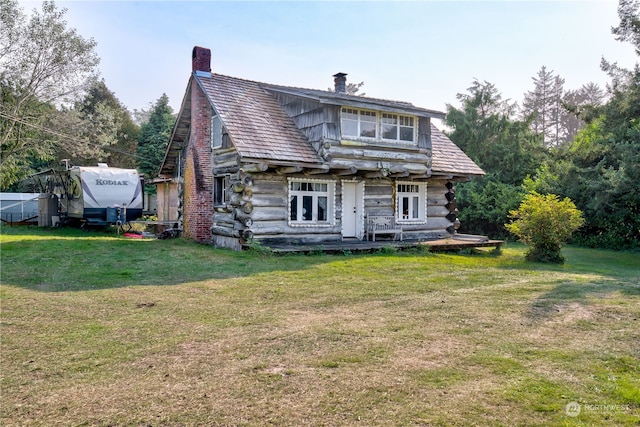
0 0 99 188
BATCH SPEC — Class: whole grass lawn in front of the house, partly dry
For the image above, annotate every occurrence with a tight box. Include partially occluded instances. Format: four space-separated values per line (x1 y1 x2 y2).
0 226 640 426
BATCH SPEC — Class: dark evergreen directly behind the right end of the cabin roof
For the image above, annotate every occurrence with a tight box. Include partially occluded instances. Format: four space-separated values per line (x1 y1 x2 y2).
446 80 546 237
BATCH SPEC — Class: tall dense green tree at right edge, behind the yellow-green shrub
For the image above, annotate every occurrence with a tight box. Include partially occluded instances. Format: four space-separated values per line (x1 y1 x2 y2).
533 0 640 249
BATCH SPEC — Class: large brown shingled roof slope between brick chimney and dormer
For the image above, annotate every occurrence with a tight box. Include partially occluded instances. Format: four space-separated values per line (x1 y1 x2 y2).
195 74 322 163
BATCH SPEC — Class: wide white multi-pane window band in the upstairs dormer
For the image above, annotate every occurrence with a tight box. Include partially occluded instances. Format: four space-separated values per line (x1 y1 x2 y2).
340 108 417 143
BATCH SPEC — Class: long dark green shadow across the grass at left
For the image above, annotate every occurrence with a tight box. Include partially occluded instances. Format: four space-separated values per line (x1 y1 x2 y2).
0 229 336 292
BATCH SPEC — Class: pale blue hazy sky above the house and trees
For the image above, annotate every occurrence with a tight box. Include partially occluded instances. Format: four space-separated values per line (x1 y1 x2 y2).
20 0 637 118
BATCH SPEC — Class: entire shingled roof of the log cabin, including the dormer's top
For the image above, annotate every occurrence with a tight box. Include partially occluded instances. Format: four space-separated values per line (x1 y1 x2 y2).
160 73 484 176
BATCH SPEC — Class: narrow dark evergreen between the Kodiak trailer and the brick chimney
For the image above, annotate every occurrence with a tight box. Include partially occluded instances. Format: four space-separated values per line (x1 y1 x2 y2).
138 94 176 192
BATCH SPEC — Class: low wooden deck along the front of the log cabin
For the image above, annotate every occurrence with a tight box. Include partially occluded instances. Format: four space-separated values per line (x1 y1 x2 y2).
258 234 504 253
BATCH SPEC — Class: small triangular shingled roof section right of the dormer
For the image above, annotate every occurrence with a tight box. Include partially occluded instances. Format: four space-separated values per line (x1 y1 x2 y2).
431 124 484 175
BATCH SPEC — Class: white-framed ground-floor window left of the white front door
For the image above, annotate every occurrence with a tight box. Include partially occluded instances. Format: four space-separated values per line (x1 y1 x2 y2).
288 178 335 226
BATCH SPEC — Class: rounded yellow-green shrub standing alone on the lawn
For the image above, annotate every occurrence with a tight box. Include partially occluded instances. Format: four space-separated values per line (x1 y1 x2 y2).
505 191 584 264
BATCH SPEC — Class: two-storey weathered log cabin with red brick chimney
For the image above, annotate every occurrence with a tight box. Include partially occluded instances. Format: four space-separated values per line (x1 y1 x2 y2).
158 47 484 250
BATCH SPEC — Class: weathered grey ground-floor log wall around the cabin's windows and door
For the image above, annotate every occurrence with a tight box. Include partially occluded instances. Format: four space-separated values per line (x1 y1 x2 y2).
211 171 460 249
